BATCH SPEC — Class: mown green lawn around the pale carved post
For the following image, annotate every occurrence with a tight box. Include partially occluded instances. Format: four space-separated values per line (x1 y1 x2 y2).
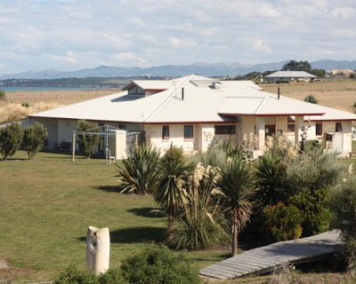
0 151 228 282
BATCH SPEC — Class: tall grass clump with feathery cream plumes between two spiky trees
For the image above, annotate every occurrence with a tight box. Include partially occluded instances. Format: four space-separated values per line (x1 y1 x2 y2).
170 163 230 250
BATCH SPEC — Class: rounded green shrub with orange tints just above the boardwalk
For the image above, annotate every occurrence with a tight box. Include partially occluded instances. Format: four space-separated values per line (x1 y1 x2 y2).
263 202 303 241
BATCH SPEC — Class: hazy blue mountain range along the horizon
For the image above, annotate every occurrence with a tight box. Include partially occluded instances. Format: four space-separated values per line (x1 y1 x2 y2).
0 60 356 80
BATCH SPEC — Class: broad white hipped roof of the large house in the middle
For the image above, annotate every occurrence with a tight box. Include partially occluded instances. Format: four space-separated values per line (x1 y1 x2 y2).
31 75 356 124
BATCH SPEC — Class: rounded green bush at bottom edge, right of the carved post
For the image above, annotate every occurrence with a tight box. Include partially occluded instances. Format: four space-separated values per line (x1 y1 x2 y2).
121 246 201 284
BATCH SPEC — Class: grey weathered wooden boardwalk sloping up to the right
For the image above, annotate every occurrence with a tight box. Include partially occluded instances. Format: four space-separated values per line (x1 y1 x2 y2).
200 230 344 279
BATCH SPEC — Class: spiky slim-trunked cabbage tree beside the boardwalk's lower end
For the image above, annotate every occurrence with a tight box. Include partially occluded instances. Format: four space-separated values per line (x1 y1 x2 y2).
217 156 253 255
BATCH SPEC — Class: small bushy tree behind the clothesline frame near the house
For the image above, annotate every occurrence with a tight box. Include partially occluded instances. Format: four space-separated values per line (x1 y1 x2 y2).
77 120 100 159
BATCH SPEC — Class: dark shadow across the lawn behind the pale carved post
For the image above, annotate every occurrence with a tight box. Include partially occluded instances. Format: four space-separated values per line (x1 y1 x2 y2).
78 227 167 244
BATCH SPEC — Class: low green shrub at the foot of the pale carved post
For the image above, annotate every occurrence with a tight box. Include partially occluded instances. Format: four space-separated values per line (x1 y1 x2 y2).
53 266 128 284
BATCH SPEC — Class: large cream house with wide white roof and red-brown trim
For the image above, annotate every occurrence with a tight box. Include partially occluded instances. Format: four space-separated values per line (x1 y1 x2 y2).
30 75 356 154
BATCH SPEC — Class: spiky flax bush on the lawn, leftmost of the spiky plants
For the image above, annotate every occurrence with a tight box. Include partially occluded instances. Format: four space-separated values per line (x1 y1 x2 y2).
118 144 160 194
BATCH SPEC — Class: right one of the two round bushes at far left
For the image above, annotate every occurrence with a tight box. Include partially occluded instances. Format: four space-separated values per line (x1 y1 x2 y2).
22 122 48 160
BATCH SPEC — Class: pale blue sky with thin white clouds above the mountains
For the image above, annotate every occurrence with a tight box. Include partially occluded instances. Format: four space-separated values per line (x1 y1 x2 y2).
0 0 356 74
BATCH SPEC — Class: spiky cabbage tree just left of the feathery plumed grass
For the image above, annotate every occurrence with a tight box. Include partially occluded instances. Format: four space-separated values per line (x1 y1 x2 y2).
154 147 194 242
